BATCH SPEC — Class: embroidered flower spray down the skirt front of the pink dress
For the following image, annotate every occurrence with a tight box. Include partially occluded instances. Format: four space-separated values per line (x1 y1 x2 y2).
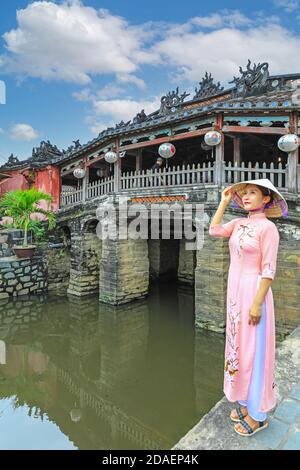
224 299 240 385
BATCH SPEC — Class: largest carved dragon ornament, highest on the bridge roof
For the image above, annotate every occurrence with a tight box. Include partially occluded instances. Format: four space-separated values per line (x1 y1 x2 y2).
229 59 272 97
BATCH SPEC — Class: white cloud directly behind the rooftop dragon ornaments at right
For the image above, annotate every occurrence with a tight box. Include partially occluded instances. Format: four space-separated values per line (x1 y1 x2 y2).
154 23 300 86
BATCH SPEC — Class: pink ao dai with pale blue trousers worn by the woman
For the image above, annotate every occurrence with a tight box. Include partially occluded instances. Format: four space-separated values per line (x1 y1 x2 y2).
209 213 279 420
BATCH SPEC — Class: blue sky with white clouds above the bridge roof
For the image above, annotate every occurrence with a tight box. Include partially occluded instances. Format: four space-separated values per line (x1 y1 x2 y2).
0 0 300 164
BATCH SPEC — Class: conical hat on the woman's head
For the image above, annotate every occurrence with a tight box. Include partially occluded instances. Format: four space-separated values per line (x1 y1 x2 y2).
231 178 288 217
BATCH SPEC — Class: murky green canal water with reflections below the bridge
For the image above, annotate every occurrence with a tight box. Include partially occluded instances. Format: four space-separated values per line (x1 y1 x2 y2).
0 283 224 449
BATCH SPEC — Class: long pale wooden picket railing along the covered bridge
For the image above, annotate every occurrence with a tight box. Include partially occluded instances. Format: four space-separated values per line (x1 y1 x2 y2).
61 162 294 207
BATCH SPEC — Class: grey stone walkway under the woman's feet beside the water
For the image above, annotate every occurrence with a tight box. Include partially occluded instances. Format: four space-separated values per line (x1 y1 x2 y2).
173 326 300 450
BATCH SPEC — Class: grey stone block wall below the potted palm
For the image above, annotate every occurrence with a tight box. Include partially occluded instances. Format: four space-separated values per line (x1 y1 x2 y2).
0 256 48 299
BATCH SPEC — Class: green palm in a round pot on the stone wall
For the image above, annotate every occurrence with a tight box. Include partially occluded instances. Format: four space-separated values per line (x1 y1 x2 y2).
0 188 55 258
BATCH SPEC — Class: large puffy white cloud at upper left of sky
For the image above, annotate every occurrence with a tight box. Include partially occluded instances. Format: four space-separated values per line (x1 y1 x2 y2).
0 1 153 85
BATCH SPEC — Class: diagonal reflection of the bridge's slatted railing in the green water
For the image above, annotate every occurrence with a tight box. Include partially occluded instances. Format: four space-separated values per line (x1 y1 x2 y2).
58 368 172 450
